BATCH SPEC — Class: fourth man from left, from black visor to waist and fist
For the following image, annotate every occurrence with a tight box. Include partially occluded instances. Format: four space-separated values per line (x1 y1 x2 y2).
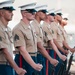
42 13 66 61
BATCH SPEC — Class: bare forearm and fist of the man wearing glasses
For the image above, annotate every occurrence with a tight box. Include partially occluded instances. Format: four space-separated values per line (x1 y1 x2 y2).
18 46 42 71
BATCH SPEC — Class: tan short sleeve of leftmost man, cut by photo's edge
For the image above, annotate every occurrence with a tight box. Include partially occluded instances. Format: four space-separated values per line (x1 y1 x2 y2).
0 31 8 49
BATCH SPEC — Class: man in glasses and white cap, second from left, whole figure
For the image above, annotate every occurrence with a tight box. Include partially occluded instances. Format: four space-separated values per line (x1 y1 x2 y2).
13 3 42 75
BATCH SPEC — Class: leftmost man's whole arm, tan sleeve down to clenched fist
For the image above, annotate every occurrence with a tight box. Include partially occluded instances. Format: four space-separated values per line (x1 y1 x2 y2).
0 31 26 75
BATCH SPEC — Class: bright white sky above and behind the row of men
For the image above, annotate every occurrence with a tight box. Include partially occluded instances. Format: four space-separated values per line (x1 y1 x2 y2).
0 0 75 33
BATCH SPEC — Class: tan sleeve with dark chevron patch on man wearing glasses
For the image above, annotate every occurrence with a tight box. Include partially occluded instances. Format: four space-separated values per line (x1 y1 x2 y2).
12 30 26 47
